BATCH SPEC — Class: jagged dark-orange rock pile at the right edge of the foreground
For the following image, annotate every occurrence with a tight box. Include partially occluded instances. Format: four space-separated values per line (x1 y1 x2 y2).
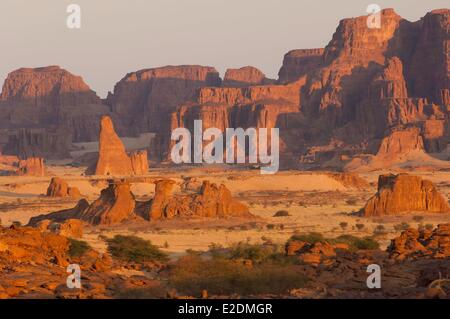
388 224 450 260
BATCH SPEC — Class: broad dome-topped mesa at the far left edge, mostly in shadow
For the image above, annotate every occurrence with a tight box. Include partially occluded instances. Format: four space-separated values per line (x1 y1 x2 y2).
0 66 109 158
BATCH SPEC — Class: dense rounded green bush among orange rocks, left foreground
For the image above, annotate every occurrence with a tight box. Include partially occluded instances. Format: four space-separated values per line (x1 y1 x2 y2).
107 235 167 262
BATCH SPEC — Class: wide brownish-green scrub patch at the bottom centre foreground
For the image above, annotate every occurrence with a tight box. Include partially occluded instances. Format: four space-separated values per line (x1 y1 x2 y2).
168 256 306 296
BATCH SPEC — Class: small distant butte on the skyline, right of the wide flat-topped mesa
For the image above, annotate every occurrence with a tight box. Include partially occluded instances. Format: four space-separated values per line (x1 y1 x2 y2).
222 66 274 87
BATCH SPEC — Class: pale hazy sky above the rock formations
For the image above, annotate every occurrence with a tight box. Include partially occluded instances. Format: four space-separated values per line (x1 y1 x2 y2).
0 0 449 97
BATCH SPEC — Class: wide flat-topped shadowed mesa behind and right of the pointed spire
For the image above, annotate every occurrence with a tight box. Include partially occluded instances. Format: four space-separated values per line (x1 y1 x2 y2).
107 65 221 132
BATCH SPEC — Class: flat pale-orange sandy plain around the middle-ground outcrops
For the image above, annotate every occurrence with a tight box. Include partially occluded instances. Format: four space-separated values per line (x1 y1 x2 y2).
0 165 450 256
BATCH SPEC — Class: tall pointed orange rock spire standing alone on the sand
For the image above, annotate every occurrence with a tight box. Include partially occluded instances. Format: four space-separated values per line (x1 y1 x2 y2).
95 116 148 175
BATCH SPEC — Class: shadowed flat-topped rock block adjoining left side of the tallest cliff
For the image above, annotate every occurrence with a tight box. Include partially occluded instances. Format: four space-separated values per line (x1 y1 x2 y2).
278 49 324 83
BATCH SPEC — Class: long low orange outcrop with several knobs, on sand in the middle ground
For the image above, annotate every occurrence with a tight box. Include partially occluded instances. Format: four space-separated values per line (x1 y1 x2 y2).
28 180 253 227
